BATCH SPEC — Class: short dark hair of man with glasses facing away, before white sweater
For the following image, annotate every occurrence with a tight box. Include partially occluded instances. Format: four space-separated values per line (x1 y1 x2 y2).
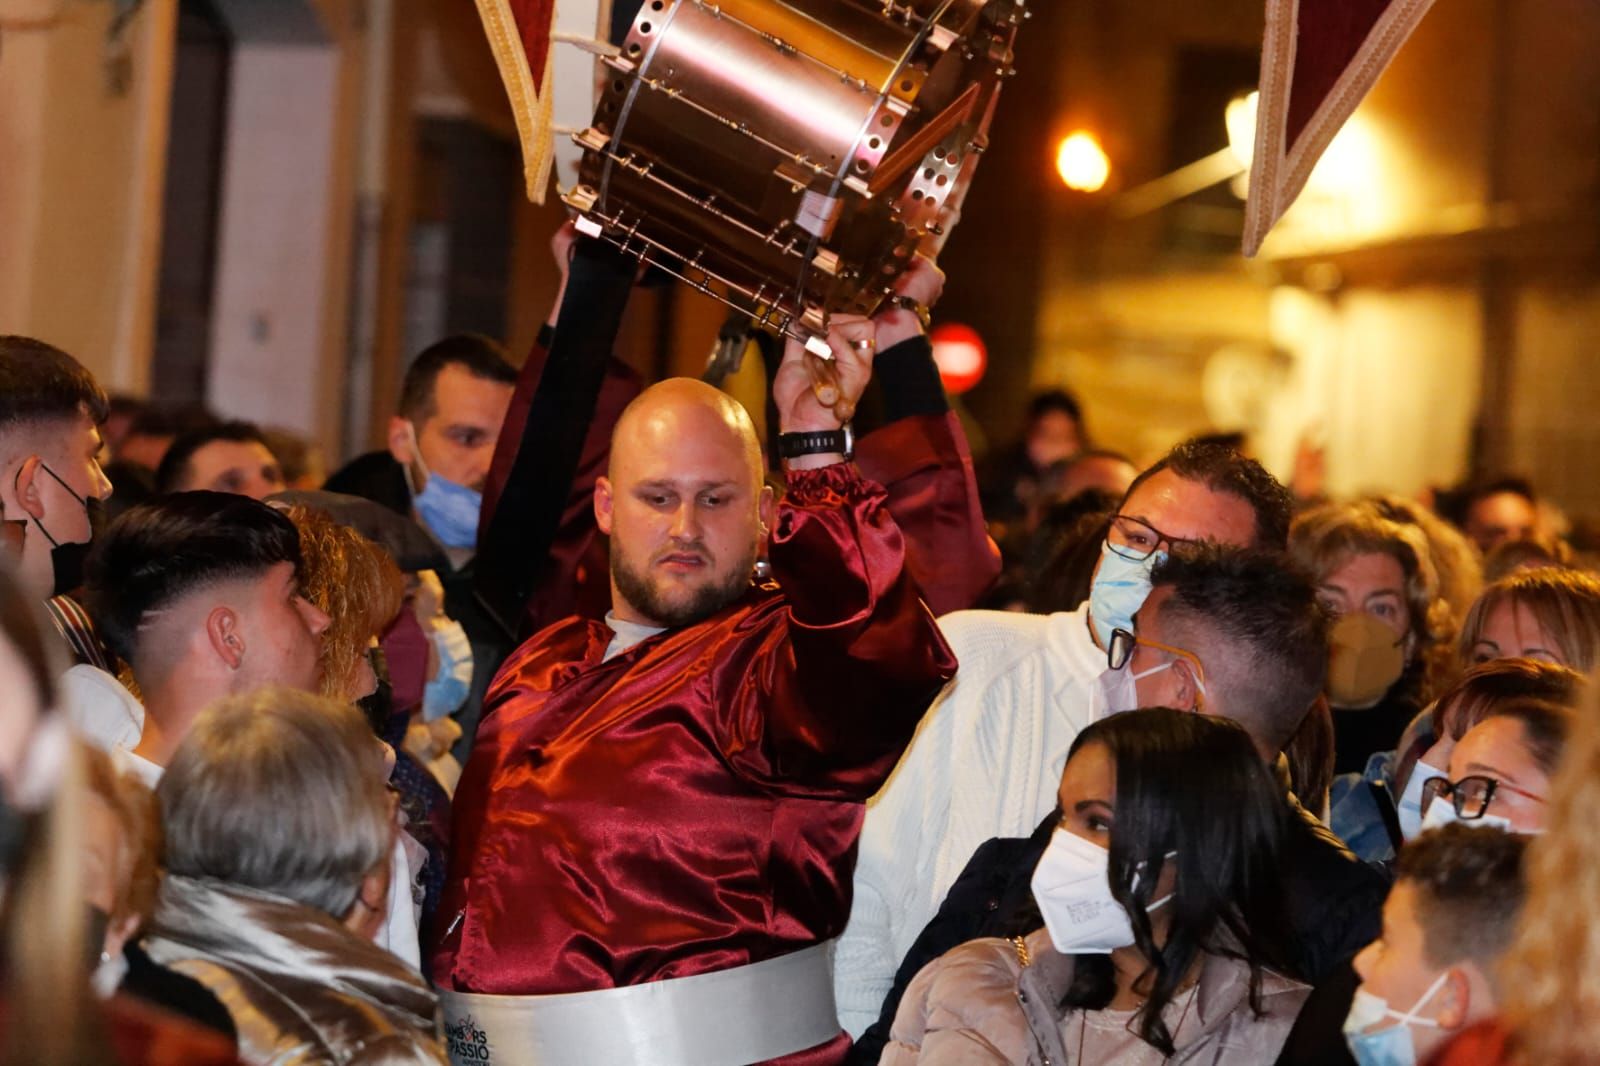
1152 544 1328 751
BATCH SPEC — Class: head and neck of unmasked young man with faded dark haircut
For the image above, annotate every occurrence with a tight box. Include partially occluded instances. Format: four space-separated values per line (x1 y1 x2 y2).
85 491 328 781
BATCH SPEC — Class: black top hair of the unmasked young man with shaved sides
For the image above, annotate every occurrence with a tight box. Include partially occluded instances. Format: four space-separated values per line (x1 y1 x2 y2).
85 491 301 666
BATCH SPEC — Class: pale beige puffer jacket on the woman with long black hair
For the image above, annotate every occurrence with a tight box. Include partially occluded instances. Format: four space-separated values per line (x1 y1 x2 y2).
880 930 1310 1066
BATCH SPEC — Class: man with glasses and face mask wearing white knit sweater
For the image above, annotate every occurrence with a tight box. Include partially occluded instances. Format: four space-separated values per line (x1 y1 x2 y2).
834 442 1299 1043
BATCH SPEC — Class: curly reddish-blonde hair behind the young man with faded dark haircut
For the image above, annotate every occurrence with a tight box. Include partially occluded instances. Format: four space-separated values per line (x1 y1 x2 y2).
286 504 405 699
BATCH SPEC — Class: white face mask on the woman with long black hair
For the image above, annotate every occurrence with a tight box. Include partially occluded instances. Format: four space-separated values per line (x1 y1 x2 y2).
1032 829 1171 956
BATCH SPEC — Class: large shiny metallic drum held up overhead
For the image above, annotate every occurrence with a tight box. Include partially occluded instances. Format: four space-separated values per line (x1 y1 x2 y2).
565 0 1026 339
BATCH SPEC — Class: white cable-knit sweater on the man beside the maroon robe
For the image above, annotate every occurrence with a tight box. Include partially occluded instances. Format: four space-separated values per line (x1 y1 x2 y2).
834 603 1106 1036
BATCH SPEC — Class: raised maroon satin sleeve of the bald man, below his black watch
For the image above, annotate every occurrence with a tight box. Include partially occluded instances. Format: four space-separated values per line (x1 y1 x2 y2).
714 463 955 800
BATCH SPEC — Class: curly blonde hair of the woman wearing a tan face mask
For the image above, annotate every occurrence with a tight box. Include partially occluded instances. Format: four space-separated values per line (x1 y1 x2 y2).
1290 503 1456 703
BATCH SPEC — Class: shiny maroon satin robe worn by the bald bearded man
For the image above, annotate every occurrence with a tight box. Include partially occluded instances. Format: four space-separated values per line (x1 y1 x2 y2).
432 464 955 1063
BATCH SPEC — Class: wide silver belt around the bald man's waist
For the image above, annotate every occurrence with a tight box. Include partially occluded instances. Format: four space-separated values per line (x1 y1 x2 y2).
438 941 840 1066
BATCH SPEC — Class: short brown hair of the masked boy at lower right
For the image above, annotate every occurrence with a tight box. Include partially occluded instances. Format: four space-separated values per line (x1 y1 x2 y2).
1395 823 1528 980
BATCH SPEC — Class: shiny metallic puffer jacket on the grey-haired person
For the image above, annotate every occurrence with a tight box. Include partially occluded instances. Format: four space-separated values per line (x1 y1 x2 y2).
144 876 448 1066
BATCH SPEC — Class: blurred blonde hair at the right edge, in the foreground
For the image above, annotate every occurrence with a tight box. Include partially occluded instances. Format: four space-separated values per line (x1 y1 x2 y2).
1499 665 1600 1066
